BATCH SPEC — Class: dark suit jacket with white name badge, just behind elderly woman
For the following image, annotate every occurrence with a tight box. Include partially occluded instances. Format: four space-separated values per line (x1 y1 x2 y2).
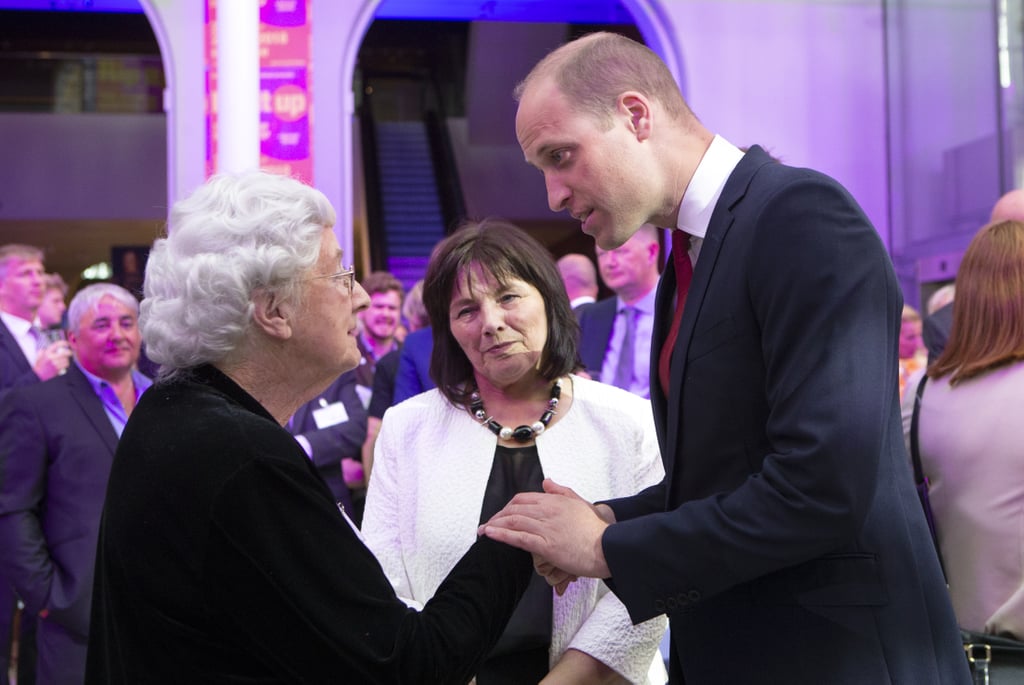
289 371 367 512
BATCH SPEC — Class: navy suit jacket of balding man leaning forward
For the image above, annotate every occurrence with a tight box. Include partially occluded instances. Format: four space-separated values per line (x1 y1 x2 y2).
602 146 970 685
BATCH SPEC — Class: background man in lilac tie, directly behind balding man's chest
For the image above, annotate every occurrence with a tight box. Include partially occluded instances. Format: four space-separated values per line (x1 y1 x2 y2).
577 224 660 397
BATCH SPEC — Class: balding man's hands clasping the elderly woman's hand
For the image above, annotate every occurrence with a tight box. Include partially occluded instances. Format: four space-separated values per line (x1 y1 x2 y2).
478 478 615 595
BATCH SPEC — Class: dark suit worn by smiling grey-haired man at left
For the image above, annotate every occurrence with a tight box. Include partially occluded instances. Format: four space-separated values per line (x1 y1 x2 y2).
0 363 118 684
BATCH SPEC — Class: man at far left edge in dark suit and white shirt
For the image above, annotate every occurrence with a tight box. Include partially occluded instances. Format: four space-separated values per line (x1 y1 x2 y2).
0 244 71 685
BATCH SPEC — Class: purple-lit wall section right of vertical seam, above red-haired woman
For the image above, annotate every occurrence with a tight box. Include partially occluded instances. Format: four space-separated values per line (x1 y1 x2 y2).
890 0 1000 268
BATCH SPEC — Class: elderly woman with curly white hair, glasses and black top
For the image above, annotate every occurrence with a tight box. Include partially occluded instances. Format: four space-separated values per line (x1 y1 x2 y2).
87 167 532 683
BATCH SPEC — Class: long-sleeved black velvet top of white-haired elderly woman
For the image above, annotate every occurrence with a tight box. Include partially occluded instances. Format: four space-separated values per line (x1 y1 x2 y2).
86 367 535 685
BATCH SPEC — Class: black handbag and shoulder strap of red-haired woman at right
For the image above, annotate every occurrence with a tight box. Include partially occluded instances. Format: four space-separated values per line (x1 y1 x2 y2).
910 376 1024 685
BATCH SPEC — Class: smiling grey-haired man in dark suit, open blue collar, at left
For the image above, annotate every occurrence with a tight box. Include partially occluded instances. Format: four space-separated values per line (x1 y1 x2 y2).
0 284 150 685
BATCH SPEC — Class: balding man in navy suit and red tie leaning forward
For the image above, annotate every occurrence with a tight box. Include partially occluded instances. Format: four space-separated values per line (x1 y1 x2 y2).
484 34 970 685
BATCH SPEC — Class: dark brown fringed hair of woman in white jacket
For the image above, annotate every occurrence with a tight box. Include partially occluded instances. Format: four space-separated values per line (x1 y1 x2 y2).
423 219 580 404
